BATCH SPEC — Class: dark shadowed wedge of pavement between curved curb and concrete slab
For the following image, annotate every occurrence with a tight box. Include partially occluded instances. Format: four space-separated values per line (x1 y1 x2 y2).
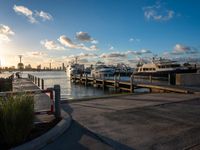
42 121 113 150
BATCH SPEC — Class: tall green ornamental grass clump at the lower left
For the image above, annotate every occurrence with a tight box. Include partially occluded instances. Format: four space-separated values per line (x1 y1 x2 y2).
0 94 34 146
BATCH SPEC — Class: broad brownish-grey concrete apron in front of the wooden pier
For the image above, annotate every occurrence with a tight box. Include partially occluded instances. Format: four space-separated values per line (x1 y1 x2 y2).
62 93 200 150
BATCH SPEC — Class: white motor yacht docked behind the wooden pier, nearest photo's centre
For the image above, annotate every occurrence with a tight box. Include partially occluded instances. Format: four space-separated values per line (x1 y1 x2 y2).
91 62 115 78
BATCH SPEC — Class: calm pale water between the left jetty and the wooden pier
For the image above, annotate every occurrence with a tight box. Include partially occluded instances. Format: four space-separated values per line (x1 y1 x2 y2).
23 71 119 99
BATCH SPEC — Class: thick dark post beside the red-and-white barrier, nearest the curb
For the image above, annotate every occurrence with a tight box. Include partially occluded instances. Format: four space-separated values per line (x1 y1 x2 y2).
54 85 61 119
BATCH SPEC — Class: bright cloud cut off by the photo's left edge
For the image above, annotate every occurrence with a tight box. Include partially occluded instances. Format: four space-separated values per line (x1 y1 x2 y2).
0 24 15 42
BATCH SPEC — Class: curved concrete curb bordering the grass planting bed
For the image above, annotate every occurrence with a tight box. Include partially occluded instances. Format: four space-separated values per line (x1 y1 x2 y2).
11 111 72 150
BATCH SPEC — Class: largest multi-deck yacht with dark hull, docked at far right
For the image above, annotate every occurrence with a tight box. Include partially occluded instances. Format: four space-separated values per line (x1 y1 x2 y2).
133 58 197 77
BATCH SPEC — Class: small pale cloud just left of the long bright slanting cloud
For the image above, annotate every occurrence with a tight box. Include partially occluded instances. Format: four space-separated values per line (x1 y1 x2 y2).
40 40 66 50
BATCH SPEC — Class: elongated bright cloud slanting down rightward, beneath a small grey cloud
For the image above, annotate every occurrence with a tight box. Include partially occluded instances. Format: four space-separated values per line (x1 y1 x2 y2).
58 35 98 51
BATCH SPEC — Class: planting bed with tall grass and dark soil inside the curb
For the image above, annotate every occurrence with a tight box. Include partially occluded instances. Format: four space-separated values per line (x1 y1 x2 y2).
0 93 60 150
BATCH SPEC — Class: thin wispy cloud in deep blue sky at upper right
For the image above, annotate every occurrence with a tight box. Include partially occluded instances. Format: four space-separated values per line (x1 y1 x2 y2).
143 3 175 21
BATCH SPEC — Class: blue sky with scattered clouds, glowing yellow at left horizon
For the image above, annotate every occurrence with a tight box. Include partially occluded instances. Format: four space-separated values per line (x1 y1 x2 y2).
0 0 200 67
